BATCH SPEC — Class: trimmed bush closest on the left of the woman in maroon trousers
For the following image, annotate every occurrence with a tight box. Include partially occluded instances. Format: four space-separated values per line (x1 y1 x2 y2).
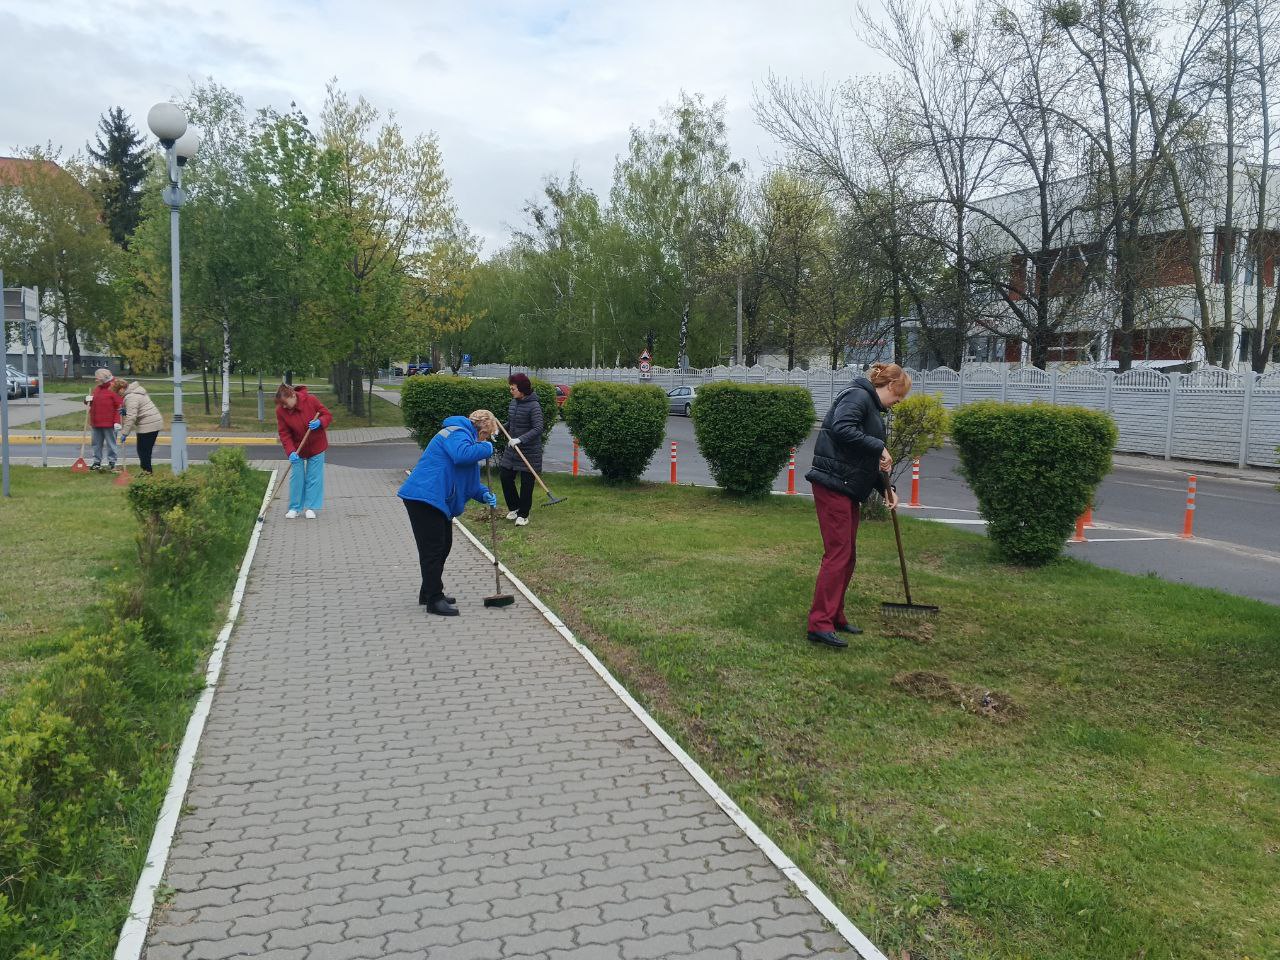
690 381 814 497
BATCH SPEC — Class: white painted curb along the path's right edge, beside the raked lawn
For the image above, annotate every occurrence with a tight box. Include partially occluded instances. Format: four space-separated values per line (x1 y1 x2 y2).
455 520 888 960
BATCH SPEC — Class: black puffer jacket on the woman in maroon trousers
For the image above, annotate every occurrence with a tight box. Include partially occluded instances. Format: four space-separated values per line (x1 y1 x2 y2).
805 376 884 503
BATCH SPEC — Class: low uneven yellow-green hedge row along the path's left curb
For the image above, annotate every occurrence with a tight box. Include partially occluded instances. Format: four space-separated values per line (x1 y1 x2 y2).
0 451 265 957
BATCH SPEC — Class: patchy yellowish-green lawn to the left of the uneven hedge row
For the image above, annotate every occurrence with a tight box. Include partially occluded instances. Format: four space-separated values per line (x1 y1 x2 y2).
0 466 137 700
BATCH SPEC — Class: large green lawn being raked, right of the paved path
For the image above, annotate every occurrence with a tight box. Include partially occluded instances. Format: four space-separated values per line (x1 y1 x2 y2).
472 476 1280 960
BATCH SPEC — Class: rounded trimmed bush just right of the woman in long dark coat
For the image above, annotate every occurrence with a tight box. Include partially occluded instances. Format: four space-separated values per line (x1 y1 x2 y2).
563 381 667 483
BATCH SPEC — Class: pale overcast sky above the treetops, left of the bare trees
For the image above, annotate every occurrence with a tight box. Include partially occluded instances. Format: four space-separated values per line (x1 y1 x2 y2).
0 0 883 252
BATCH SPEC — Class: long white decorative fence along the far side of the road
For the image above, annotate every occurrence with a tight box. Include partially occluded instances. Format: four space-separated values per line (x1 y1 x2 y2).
472 364 1280 467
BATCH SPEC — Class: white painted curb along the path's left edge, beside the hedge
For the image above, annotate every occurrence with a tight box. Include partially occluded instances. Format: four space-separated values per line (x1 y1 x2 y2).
115 470 276 960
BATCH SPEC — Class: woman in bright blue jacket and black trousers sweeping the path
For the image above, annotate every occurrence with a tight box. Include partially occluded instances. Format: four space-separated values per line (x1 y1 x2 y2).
399 410 498 617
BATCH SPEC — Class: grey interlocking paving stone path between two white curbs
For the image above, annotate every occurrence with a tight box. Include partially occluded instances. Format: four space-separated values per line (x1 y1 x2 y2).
146 466 856 960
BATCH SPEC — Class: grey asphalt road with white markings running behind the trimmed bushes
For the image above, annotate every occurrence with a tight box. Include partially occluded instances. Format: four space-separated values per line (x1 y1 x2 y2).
13 417 1280 605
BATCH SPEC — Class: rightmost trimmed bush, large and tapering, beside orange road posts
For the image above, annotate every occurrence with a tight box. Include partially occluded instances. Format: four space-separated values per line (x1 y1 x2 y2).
951 401 1119 566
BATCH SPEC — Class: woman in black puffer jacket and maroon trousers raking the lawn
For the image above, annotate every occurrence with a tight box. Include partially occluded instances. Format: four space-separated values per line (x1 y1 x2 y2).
805 364 911 646
